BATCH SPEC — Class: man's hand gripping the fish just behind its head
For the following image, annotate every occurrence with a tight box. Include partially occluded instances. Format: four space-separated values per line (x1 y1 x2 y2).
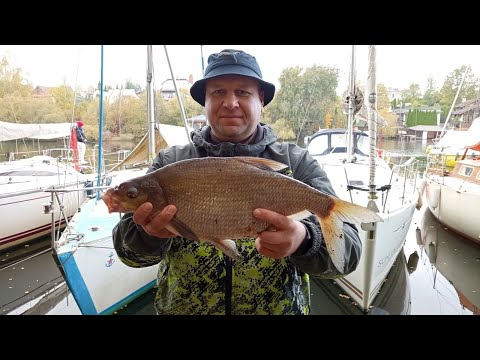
133 202 177 238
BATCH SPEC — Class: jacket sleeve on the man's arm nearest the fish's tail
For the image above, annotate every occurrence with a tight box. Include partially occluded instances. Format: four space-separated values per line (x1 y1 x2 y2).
272 145 362 278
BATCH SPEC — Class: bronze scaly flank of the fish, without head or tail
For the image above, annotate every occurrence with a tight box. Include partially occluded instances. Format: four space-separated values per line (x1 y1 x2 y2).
163 158 312 240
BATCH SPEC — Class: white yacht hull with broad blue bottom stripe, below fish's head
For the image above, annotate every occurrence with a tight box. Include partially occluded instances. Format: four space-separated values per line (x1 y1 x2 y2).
54 169 157 315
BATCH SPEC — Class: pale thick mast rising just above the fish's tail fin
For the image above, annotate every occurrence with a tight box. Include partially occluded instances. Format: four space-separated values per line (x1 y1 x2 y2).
366 45 378 208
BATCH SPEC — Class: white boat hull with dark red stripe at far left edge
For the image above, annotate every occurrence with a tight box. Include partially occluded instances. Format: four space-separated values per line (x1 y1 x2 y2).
0 156 88 251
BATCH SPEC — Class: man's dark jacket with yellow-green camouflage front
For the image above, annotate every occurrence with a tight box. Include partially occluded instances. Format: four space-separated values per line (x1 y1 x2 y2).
113 124 361 314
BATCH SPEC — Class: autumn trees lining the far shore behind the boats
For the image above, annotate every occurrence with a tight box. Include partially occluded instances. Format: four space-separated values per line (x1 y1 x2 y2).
0 50 478 145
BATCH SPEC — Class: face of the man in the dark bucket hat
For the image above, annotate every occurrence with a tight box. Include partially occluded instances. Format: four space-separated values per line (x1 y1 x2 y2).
205 75 264 143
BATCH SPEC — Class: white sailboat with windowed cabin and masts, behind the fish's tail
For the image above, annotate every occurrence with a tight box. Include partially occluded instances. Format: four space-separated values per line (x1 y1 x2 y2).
307 45 419 313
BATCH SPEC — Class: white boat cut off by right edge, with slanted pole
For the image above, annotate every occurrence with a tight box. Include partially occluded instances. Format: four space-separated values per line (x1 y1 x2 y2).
425 67 480 243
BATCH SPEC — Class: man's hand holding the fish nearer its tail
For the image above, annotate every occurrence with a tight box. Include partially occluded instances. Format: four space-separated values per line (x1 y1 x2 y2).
253 209 307 259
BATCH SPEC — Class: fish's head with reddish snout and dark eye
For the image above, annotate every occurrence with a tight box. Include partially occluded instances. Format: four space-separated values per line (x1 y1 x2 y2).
101 178 167 213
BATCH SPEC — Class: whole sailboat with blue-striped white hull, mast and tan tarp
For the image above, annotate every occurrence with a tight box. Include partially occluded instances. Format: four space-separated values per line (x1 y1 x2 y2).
45 45 188 315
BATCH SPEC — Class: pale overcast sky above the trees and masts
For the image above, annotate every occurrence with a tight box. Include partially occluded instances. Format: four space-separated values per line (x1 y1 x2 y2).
0 45 480 94
